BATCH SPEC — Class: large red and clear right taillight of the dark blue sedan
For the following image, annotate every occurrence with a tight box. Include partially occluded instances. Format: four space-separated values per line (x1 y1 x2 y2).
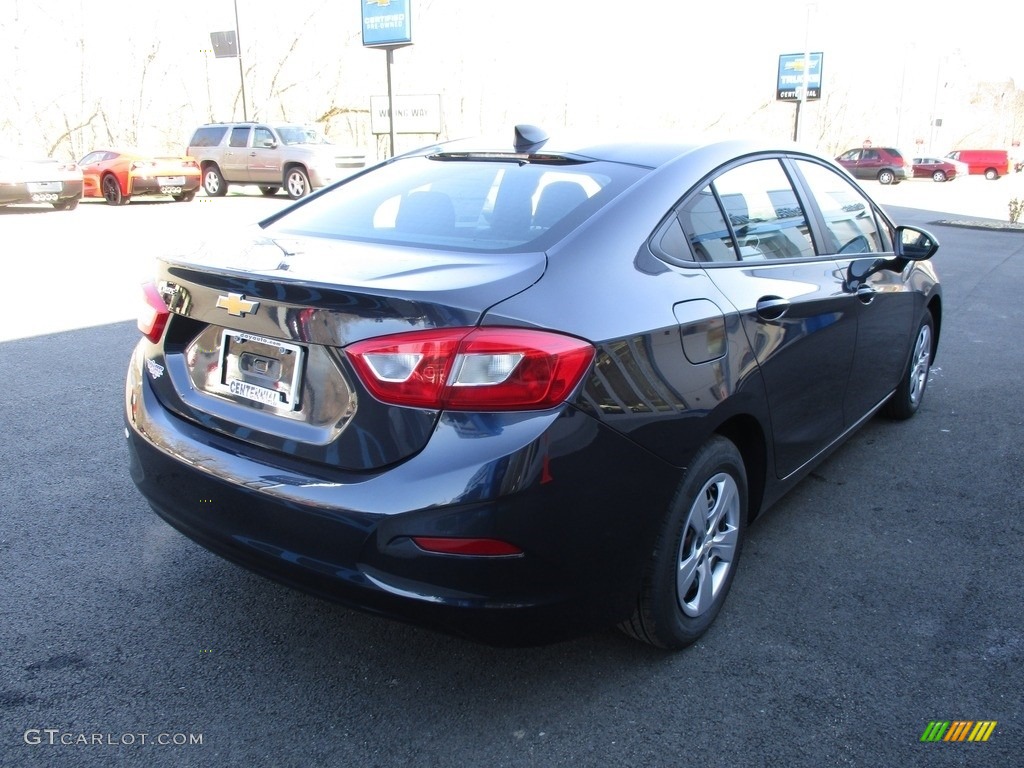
345 328 594 411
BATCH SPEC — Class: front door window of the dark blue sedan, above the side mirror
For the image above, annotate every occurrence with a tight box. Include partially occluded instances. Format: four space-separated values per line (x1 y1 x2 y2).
796 160 891 255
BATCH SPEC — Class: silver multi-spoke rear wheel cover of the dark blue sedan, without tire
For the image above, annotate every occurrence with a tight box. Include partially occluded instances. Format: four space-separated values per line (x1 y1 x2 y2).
676 472 740 616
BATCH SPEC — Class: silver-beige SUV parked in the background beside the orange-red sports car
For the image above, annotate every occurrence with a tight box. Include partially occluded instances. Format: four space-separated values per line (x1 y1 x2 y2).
185 123 366 200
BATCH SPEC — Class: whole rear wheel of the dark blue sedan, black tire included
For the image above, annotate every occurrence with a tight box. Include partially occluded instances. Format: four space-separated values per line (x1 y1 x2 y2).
618 435 748 650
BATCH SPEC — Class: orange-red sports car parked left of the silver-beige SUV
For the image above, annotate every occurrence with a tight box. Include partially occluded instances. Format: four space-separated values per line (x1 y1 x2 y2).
79 150 202 206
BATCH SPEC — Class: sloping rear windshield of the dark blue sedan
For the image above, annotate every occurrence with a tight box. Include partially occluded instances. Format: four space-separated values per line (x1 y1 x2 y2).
268 157 646 251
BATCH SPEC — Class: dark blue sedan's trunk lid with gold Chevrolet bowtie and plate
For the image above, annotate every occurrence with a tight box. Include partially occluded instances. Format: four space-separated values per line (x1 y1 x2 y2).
147 230 546 471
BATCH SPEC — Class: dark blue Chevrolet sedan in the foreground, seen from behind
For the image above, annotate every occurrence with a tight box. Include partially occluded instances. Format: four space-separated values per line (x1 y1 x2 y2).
125 126 941 648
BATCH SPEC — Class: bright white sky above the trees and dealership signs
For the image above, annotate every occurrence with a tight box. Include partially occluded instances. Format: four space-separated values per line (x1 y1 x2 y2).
0 0 1024 156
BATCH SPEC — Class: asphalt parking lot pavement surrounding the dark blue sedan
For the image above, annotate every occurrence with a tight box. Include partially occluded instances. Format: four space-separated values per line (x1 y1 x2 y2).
0 179 1024 768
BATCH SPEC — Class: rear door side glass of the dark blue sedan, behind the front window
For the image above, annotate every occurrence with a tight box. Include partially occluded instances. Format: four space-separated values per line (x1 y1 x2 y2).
660 159 815 262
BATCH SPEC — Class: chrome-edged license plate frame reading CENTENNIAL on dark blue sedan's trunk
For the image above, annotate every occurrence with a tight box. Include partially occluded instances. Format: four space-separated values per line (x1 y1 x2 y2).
220 329 306 412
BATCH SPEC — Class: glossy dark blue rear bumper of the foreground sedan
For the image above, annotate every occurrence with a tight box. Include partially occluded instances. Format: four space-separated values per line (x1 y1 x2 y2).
126 345 678 645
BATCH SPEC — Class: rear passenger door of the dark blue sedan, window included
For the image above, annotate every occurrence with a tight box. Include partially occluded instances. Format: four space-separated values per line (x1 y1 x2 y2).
679 157 857 477
